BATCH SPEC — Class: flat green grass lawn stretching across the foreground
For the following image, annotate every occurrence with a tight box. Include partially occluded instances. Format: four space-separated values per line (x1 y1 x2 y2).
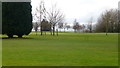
2 32 118 66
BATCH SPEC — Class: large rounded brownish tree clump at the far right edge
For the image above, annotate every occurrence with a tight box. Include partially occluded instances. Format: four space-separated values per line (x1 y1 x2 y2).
96 9 119 35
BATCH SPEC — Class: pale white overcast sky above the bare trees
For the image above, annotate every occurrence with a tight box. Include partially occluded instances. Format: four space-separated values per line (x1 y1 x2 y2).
31 0 119 24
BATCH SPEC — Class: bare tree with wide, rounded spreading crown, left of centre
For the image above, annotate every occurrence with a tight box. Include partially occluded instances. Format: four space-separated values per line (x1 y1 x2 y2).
47 5 64 35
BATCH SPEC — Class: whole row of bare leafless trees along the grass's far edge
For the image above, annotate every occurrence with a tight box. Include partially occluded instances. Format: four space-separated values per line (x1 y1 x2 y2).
33 1 119 35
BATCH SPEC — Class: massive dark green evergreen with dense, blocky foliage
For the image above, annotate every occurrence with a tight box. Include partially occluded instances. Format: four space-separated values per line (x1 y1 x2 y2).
2 2 32 38
